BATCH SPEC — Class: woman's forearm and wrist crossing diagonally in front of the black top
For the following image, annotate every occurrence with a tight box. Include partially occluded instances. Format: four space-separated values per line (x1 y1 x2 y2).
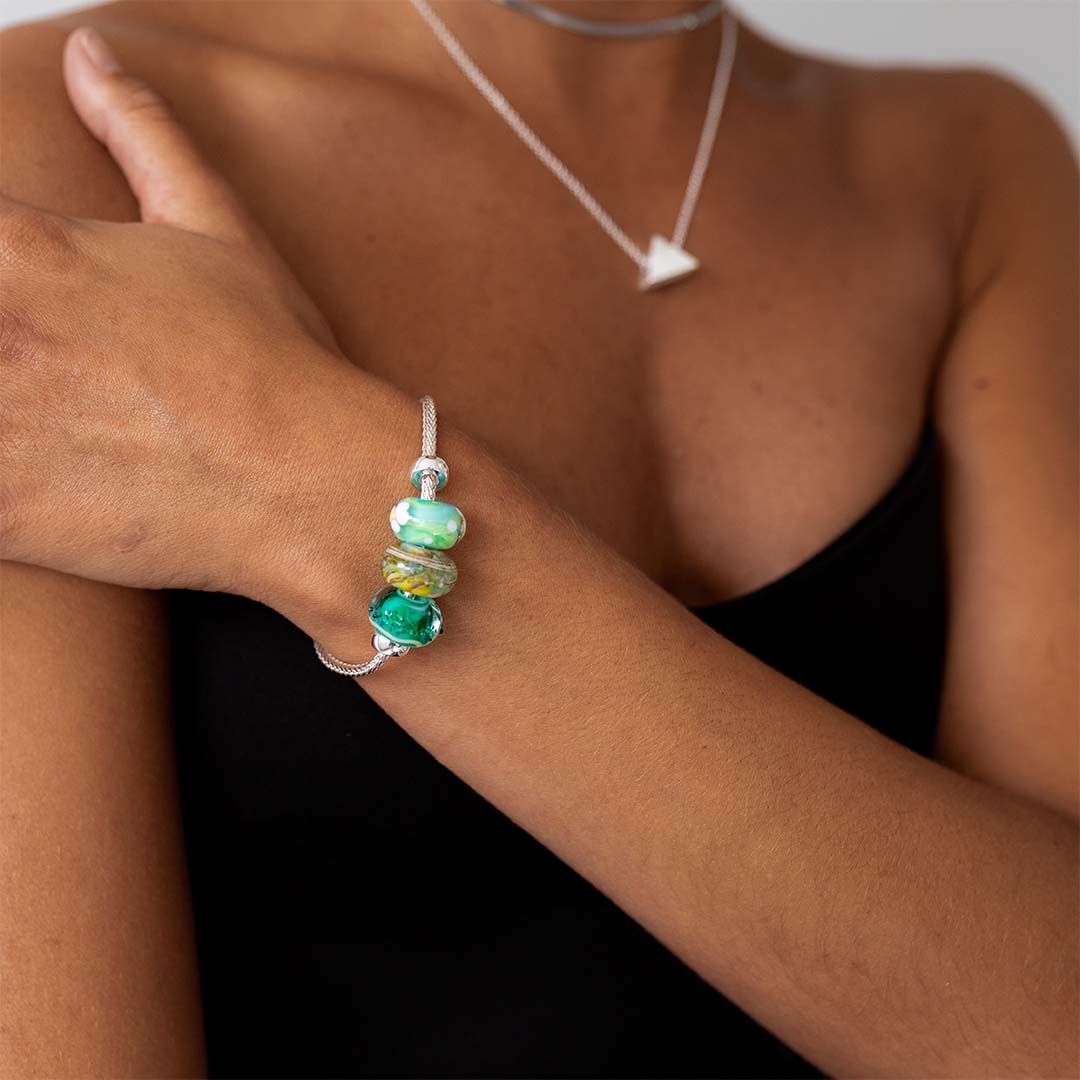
286 376 1077 1076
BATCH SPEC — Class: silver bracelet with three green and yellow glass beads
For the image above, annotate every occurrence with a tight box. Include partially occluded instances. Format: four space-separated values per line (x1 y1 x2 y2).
314 396 465 675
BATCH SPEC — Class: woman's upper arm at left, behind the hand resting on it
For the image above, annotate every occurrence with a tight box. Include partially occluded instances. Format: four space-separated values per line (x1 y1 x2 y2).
0 16 202 1077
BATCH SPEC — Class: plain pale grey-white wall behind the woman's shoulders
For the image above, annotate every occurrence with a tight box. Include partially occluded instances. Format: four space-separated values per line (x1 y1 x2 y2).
6 0 1080 141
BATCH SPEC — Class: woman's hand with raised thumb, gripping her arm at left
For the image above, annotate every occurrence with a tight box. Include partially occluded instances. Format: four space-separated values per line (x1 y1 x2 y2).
0 30 393 613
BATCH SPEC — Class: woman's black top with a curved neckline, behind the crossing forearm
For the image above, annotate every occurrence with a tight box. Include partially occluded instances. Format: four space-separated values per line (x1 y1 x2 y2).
171 422 946 1078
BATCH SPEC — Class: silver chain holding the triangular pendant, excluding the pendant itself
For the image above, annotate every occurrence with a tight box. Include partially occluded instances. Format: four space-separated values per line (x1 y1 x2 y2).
409 0 738 268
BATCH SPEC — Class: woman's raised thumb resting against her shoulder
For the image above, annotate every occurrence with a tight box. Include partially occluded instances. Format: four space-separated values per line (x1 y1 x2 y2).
64 27 258 240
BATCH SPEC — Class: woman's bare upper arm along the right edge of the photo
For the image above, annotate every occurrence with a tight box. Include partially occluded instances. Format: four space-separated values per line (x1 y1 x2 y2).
934 75 1080 815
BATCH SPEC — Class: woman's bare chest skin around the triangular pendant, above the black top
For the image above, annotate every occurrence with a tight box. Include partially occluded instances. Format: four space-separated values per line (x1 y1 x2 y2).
185 54 948 604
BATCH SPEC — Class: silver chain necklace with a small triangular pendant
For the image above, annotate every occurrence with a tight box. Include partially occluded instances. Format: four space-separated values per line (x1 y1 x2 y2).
410 0 739 289
